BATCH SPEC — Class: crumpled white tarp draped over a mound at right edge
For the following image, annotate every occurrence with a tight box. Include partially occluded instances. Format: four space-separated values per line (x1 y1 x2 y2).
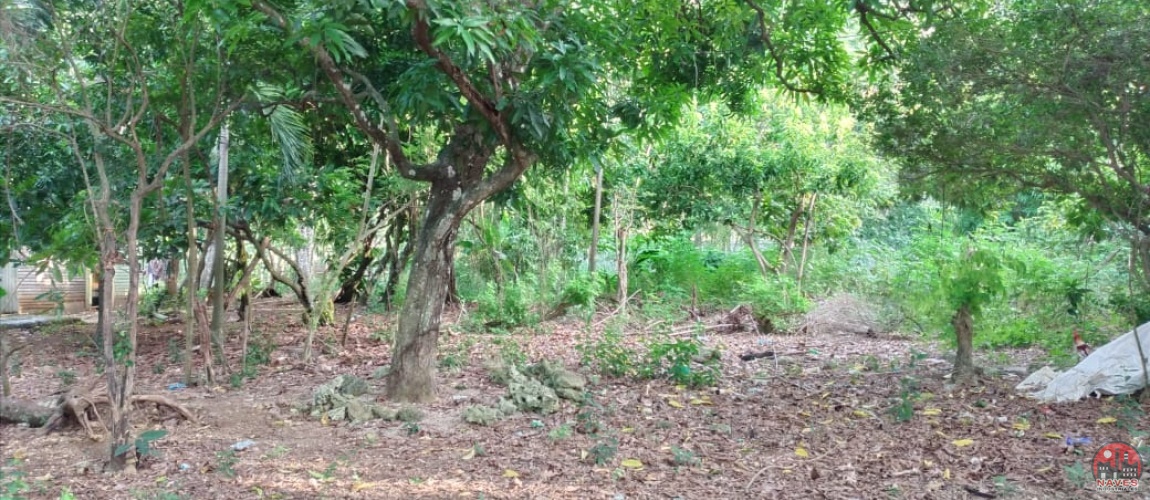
1015 323 1150 402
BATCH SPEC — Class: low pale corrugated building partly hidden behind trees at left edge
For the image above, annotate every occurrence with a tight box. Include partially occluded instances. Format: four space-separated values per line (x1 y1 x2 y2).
0 262 129 314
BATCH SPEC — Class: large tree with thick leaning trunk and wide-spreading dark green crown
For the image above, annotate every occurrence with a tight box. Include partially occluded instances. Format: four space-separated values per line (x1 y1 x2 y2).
225 0 930 401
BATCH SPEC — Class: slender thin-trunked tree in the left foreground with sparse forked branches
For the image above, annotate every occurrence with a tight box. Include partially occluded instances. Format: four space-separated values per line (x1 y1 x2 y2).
0 2 239 470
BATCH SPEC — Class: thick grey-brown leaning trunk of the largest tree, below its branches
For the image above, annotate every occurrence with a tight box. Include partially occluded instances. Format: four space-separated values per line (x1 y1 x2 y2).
388 184 466 402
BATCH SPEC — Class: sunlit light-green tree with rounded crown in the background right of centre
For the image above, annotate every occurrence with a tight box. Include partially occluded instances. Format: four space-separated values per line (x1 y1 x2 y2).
642 94 894 282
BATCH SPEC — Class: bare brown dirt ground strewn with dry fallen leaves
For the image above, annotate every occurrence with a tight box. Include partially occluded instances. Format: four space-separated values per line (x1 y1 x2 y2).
0 298 1148 499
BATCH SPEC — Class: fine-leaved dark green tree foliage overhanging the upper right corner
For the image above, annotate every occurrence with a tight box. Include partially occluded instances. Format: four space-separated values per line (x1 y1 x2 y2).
863 0 1150 291
